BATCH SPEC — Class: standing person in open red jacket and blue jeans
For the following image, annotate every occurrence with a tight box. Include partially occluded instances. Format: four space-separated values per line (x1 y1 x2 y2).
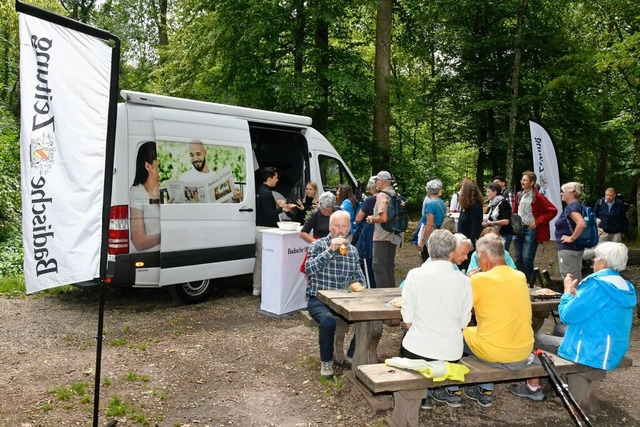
512 171 558 283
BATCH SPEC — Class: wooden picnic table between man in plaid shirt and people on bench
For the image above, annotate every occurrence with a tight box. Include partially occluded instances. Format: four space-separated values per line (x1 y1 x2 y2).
317 288 560 372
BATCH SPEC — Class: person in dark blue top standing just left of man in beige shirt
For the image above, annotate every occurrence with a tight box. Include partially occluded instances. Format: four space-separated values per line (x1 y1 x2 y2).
353 176 378 288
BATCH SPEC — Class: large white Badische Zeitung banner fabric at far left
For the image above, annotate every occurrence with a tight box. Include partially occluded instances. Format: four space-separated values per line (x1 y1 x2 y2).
20 13 112 293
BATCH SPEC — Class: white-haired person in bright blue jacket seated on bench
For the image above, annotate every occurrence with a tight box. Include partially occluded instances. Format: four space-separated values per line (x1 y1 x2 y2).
509 242 636 400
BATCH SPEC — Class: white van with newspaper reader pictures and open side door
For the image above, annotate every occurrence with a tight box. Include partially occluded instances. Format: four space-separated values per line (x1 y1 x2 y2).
107 91 356 303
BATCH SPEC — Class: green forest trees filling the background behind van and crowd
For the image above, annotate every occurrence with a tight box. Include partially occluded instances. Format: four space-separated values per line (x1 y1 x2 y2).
0 0 640 276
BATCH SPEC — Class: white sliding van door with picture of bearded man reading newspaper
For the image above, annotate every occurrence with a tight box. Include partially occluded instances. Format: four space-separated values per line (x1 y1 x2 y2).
153 108 255 285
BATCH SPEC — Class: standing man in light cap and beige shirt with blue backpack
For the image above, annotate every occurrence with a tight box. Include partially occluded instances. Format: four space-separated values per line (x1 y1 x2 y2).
367 171 402 288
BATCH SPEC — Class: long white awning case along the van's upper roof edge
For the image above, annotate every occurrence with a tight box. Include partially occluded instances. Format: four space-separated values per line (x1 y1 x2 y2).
120 90 311 126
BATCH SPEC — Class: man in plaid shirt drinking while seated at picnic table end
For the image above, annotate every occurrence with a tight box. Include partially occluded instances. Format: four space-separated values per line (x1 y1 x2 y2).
305 211 365 378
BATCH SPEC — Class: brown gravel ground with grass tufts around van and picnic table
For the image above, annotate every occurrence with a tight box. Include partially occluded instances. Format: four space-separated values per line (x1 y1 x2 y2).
0 234 640 427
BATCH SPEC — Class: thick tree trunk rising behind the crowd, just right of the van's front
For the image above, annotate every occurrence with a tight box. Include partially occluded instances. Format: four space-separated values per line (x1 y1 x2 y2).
371 0 393 173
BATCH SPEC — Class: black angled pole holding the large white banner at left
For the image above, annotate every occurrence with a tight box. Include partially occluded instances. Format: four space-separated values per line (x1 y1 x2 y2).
16 0 120 427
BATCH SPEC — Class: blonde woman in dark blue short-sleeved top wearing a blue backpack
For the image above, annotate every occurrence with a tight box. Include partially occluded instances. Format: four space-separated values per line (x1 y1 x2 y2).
555 182 585 282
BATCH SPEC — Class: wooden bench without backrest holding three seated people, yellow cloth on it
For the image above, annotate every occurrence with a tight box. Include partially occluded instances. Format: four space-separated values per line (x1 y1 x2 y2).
356 353 633 427
